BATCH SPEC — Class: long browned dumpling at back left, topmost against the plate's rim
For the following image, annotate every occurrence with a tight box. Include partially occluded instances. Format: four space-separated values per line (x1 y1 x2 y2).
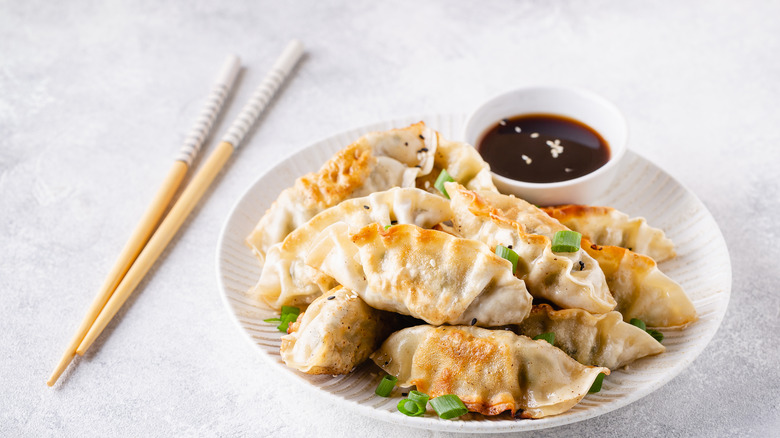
246 122 437 261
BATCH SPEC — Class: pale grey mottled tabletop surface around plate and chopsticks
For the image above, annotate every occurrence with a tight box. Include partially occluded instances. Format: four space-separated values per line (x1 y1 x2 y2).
0 0 780 437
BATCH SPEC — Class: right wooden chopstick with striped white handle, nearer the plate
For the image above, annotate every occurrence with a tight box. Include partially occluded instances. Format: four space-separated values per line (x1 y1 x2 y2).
76 40 303 354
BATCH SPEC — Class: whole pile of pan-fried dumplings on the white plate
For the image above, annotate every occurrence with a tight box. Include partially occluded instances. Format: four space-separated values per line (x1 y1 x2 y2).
246 122 697 418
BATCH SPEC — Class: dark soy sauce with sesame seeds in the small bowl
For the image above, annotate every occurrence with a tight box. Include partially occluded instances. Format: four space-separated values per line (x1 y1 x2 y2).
477 114 610 183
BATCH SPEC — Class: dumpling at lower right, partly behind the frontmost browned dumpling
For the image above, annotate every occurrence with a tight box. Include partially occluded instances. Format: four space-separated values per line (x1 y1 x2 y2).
517 304 666 370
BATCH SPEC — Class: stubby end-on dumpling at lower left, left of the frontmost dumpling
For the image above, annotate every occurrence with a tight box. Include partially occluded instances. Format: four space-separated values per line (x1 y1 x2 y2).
280 286 391 374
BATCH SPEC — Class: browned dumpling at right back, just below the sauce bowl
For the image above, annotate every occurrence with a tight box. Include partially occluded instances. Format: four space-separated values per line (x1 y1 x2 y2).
543 205 675 263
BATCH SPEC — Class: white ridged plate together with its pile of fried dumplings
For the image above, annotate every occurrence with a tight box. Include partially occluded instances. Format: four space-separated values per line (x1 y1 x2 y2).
217 115 731 433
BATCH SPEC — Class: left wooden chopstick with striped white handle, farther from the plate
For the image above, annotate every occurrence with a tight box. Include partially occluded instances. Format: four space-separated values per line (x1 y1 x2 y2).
46 55 241 386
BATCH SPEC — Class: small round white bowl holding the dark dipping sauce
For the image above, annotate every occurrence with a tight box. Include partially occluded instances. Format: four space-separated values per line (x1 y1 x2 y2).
464 86 628 206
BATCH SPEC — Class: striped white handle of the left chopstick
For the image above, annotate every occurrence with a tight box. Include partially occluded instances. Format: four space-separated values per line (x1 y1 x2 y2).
176 55 241 167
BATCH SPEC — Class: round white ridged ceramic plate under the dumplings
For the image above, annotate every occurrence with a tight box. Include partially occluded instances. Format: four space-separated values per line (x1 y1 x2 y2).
217 115 731 433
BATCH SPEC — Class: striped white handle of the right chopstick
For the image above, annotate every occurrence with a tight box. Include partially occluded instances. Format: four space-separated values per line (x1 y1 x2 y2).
222 40 303 148
